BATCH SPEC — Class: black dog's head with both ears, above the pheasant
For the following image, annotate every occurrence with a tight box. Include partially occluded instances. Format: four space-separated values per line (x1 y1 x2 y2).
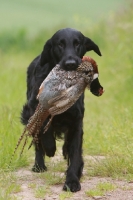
40 28 101 70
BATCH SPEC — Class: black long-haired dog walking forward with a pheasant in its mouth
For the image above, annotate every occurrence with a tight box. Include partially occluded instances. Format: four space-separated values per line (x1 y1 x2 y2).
21 28 101 192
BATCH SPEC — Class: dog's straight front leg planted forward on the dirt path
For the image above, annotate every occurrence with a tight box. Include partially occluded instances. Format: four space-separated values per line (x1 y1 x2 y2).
63 119 84 192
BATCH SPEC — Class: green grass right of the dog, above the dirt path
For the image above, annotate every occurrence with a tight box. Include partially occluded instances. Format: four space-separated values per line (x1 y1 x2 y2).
84 2 133 178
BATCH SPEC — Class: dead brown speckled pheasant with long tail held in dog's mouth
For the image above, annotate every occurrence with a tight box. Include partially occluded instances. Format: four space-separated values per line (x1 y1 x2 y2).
9 56 103 163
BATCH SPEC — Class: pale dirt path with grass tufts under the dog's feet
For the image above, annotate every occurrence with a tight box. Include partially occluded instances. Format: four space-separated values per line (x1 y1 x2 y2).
13 156 133 200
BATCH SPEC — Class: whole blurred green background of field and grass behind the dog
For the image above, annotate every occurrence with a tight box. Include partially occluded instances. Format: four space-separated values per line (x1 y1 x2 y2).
0 0 133 178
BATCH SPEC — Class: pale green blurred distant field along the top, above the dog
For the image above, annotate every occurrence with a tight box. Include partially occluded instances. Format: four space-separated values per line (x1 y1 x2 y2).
0 0 127 36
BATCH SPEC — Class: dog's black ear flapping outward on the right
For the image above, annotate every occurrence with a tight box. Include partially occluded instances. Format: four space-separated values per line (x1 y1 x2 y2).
84 37 102 56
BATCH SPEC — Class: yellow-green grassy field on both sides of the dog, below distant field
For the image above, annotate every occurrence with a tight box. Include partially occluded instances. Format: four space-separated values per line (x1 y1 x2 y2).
0 1 133 200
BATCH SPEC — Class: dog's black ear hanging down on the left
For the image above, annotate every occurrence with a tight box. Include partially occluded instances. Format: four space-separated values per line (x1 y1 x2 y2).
40 39 52 66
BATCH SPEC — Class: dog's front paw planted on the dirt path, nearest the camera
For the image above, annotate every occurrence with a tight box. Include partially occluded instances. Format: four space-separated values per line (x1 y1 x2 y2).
63 181 81 192
